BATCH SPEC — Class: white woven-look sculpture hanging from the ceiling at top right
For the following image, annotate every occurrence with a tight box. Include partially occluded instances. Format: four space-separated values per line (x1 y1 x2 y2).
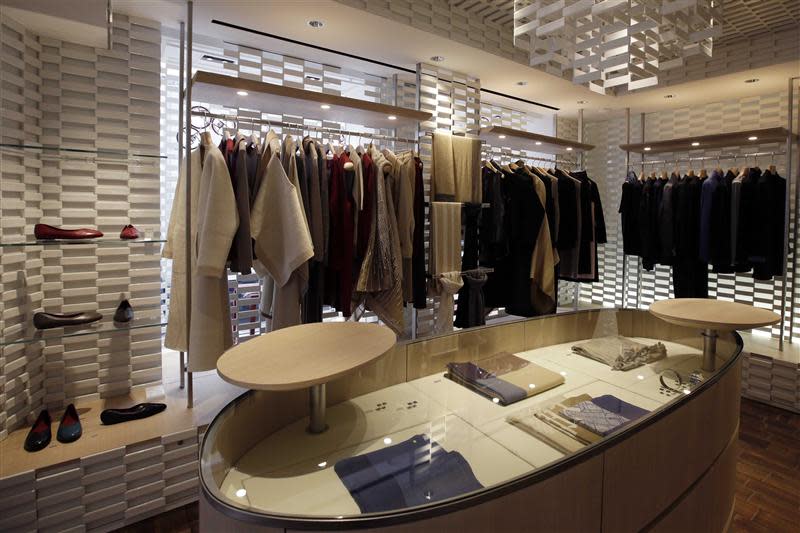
514 0 722 94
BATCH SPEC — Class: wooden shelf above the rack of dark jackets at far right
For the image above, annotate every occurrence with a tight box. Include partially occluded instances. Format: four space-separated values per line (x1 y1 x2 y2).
619 128 797 154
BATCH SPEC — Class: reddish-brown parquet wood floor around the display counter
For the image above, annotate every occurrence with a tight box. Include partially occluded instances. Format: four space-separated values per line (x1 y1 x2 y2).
119 398 800 533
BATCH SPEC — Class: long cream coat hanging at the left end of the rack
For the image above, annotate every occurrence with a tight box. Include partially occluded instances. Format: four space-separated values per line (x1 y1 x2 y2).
162 135 239 372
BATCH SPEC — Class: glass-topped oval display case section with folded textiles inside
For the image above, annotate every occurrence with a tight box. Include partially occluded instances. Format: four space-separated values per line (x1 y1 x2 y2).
200 310 742 529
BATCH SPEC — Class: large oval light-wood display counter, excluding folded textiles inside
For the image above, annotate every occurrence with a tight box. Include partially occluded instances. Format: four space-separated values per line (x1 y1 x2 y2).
200 310 742 532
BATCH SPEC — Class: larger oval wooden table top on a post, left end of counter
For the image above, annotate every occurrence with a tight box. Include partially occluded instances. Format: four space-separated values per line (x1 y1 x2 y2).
217 322 397 390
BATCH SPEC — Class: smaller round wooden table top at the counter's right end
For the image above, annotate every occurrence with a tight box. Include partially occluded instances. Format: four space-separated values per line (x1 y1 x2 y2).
650 298 781 331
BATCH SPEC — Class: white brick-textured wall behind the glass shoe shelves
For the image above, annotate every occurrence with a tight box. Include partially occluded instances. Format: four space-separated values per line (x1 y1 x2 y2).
0 14 161 437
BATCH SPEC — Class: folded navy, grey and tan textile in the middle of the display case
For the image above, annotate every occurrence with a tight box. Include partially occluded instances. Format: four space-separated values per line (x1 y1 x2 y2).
445 352 564 405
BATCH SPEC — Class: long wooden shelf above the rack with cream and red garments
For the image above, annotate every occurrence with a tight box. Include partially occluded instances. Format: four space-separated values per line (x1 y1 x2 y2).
192 70 431 128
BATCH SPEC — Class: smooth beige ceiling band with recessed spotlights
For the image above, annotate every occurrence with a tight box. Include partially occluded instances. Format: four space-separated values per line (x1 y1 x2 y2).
83 0 800 118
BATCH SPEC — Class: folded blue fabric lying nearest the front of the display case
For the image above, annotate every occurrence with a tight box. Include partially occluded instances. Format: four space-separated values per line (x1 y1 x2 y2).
333 435 483 513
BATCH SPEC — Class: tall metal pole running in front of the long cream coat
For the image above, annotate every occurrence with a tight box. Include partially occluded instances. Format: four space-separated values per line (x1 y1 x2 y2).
184 0 194 409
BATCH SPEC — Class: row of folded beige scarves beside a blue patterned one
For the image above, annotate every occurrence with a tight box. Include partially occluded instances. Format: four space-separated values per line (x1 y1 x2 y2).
506 394 649 453
